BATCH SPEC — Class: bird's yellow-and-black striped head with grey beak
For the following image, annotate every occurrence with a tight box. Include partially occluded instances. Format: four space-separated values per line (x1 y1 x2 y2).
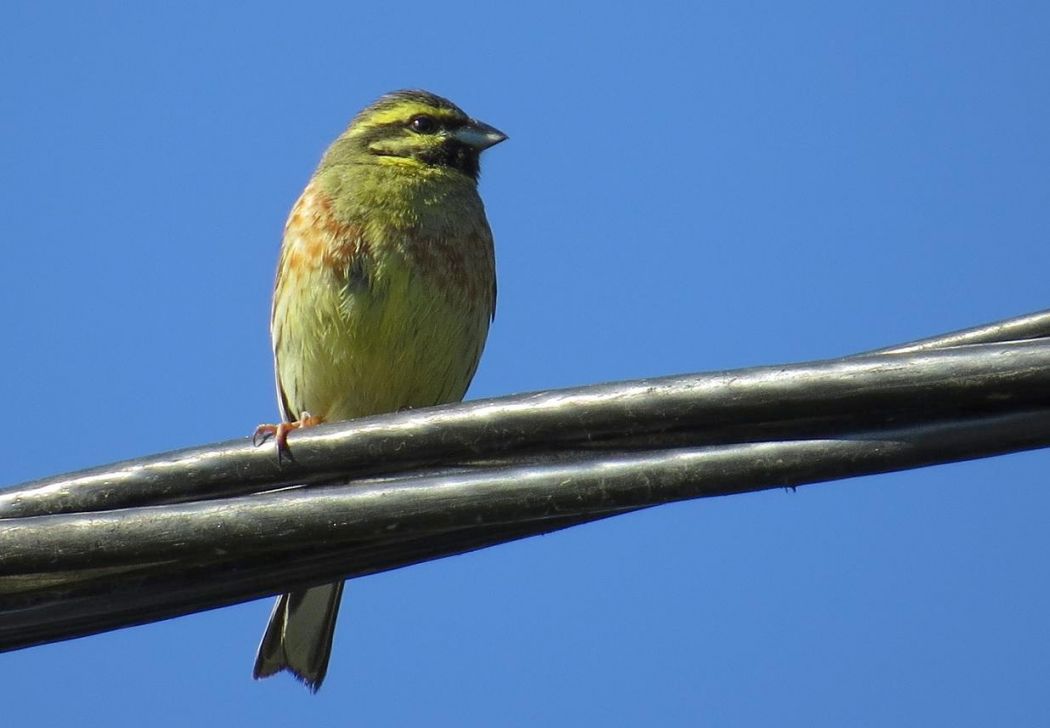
321 90 507 180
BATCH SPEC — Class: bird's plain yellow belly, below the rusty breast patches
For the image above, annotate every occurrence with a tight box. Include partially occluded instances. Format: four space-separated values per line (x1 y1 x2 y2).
273 241 490 421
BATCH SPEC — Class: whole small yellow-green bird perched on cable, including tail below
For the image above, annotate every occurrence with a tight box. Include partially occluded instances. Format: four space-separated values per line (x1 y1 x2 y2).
254 90 507 692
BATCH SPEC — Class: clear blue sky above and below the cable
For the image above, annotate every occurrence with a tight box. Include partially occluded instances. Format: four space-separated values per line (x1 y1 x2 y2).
0 0 1050 727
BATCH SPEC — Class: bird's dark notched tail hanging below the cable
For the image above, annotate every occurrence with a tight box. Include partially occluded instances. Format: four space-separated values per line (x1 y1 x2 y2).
252 581 342 692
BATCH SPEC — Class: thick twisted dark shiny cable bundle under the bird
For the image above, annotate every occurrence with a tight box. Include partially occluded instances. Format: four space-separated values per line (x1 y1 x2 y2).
0 311 1050 650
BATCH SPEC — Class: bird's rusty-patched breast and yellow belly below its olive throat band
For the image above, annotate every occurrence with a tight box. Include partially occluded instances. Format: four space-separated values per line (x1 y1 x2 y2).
272 180 495 420
